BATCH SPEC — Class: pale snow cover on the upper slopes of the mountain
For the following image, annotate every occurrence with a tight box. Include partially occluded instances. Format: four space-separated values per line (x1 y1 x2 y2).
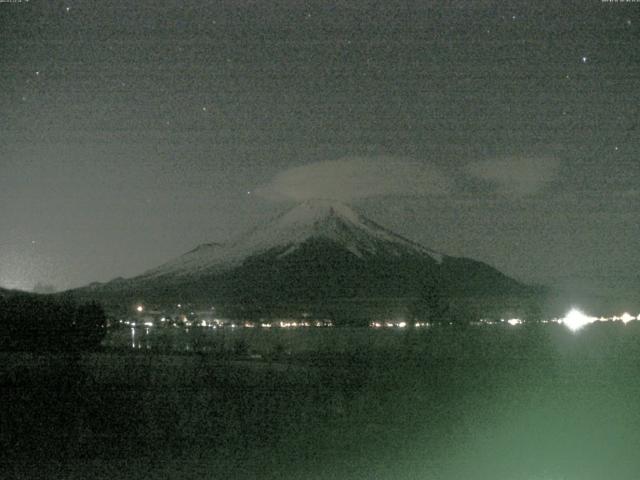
143 200 442 277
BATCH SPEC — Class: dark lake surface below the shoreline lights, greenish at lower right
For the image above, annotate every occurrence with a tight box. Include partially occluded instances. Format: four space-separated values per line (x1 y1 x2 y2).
2 322 640 480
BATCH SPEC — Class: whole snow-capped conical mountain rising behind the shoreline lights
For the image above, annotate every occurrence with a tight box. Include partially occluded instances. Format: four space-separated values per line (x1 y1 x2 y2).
74 200 535 319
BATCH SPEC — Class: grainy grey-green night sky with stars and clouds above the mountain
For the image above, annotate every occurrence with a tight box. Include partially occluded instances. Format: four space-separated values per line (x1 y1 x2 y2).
0 0 640 304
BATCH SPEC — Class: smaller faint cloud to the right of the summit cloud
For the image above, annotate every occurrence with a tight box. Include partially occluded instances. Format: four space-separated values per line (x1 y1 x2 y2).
466 157 560 196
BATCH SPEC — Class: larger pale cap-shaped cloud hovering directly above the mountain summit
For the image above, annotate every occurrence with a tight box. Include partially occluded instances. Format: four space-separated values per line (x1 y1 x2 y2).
255 157 450 201
